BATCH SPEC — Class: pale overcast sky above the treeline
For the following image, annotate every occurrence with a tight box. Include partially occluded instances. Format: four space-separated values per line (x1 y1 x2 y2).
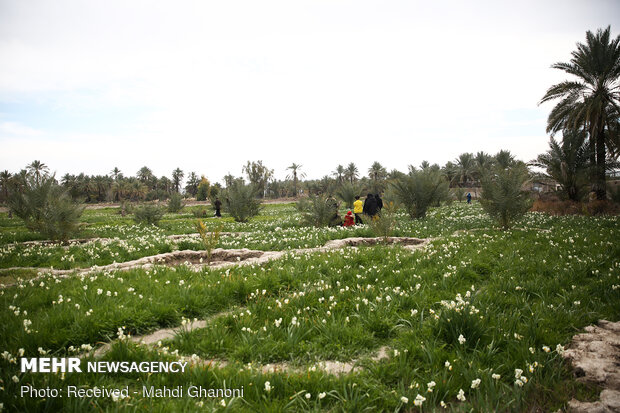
0 0 620 181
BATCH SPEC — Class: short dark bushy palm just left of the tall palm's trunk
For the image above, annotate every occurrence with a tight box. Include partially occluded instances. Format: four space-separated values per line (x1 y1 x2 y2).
530 129 590 201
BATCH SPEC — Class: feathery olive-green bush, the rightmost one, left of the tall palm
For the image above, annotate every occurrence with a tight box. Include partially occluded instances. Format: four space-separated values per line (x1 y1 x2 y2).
480 164 532 229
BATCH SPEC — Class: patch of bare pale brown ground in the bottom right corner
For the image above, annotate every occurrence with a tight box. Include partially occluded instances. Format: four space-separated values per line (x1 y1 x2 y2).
564 320 620 413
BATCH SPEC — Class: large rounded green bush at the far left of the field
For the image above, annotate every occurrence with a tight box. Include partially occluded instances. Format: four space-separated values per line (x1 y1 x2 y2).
8 175 84 241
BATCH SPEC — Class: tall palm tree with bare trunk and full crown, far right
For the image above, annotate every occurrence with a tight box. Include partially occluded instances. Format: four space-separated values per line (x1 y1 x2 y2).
540 26 620 199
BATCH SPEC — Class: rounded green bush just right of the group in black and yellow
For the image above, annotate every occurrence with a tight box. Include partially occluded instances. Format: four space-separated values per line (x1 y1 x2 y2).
391 168 449 219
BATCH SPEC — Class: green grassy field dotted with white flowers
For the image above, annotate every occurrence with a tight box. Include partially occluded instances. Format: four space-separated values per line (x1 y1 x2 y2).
0 203 620 412
